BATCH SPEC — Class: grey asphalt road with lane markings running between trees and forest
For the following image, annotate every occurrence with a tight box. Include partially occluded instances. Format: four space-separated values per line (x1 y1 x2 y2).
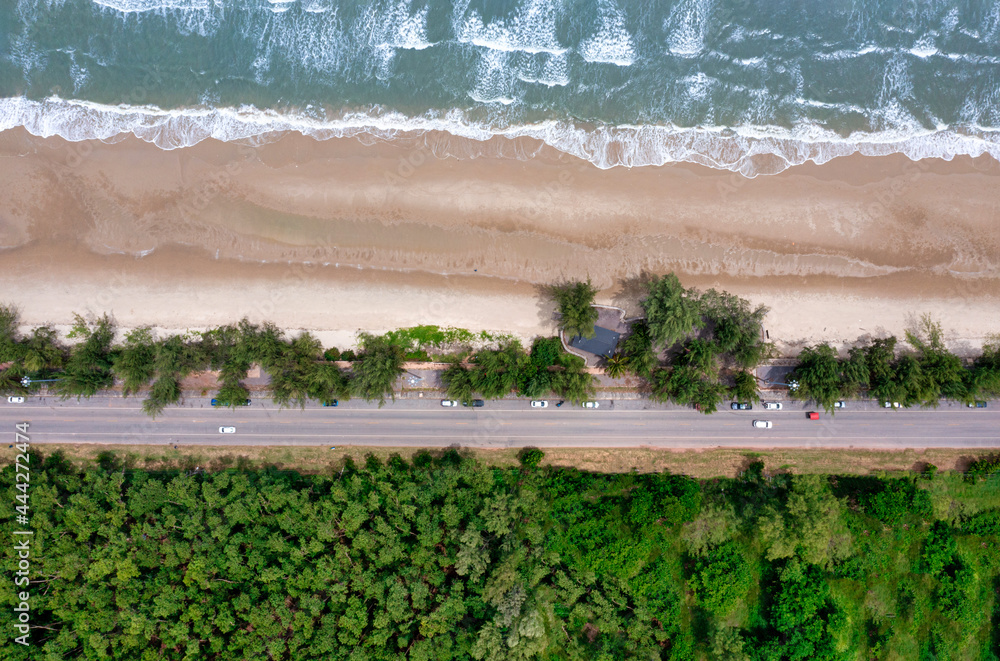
0 397 1000 449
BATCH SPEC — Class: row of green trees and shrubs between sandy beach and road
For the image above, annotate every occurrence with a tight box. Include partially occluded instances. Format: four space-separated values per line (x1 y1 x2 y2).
0 273 1000 416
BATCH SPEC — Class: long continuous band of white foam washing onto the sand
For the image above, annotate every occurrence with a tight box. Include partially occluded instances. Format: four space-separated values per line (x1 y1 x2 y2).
0 97 1000 177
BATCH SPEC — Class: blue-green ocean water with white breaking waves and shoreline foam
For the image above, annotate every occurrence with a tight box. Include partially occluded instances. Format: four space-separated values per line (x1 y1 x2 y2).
0 0 1000 176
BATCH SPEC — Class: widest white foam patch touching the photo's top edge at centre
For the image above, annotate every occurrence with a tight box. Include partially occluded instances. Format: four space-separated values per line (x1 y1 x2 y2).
453 0 567 55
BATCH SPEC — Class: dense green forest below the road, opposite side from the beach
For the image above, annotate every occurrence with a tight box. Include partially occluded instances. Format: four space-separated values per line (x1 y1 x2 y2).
0 450 1000 661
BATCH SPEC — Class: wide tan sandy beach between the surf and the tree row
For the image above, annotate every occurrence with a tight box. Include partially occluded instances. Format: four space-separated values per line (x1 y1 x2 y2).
0 129 1000 353
